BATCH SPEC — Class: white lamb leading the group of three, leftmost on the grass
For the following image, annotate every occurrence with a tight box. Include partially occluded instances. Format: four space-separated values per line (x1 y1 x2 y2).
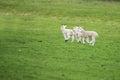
61 25 74 42
